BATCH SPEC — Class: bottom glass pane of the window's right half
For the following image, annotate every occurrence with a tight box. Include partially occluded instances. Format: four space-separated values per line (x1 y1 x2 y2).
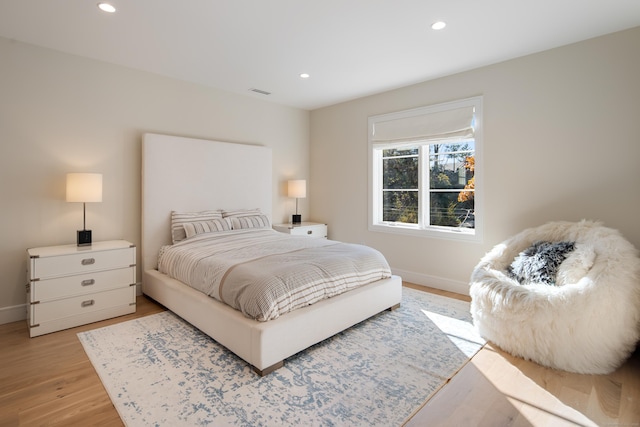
429 191 475 228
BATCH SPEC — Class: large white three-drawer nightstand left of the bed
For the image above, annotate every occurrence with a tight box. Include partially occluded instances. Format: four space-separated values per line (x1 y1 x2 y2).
27 240 136 337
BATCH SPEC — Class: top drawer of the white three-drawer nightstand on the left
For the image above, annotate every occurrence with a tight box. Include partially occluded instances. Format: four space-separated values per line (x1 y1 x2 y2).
30 248 136 280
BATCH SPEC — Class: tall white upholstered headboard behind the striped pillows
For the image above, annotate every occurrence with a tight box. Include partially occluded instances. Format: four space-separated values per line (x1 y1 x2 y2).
142 133 273 271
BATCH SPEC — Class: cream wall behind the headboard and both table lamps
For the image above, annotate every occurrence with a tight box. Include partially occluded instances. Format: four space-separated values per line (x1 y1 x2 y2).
0 38 309 323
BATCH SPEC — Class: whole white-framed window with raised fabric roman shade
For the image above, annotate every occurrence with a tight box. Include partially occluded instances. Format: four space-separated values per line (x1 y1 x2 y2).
369 97 482 241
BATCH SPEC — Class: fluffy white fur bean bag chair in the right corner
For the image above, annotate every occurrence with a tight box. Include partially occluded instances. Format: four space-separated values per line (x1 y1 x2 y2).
470 221 640 374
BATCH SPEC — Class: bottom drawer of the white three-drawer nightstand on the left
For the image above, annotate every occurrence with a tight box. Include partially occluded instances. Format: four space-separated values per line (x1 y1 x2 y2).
30 286 136 326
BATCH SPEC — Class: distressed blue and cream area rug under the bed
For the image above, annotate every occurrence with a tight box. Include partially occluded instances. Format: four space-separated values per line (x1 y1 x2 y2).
78 288 484 426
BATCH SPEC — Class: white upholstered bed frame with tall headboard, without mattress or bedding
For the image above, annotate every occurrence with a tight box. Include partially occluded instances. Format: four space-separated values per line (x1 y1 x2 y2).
141 134 402 375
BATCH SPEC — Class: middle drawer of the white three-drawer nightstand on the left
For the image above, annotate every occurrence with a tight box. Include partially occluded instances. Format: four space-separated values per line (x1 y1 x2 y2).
29 267 136 302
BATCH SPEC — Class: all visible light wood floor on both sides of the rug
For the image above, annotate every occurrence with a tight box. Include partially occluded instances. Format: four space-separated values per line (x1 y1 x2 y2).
0 284 640 427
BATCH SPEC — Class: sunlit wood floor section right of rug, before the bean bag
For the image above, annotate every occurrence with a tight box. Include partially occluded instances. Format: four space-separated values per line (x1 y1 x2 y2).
406 345 640 427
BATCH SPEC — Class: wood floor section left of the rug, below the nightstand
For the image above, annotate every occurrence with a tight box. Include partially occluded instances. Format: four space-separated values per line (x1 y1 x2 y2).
0 296 165 426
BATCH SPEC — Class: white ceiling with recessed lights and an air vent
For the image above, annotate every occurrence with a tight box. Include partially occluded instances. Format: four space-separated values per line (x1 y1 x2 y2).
0 0 640 110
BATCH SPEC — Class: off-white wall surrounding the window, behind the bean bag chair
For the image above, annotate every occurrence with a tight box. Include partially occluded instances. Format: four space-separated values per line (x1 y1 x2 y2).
309 27 640 293
